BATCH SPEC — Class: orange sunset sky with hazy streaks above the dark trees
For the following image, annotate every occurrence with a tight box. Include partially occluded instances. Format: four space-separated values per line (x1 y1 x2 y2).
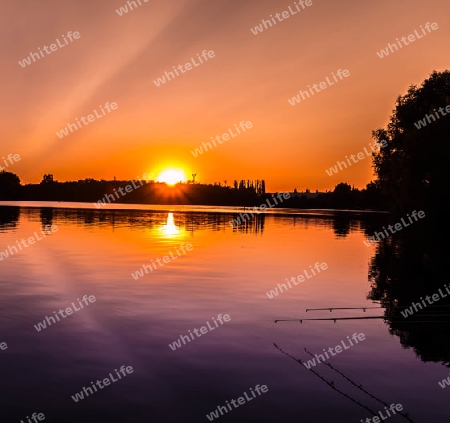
0 0 450 191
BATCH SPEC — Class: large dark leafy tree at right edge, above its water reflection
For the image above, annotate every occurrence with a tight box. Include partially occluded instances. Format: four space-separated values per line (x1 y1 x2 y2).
372 70 450 217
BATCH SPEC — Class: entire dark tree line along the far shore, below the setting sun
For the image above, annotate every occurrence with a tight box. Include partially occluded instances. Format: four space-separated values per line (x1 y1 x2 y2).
0 172 387 210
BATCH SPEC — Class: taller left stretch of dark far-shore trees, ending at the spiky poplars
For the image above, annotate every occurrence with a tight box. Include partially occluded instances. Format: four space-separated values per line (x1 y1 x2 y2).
0 175 265 206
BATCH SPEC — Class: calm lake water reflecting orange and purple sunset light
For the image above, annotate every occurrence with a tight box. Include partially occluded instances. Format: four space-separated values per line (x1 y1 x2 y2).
0 203 450 423
